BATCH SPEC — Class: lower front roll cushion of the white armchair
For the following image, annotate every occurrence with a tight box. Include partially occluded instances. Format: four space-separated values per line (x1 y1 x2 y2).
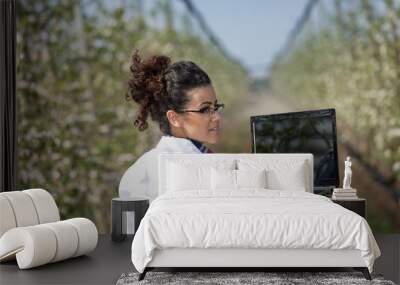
0 218 98 269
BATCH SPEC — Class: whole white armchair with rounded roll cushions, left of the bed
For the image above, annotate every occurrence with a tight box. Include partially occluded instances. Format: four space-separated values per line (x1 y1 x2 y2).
0 189 98 269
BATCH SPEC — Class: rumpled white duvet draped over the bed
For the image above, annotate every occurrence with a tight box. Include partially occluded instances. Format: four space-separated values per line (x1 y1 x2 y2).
132 189 380 272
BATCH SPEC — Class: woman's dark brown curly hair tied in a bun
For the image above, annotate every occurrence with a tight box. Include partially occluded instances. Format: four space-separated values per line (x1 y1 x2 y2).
126 50 211 134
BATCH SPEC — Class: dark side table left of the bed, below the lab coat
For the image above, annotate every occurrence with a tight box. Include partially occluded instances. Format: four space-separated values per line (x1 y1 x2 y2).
111 197 149 241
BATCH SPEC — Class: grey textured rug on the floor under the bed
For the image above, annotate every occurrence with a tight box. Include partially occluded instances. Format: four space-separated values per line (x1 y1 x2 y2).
117 271 395 285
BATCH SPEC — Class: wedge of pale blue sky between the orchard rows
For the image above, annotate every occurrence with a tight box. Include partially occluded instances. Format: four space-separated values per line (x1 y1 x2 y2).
192 0 308 75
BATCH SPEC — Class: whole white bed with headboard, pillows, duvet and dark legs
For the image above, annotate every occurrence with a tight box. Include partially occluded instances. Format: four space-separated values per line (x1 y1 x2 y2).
132 154 380 279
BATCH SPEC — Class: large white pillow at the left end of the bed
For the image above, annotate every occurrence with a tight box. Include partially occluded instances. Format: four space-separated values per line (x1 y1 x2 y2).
166 162 211 191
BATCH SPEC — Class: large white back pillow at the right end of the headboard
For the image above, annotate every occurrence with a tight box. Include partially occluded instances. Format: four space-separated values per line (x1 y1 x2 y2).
237 159 308 191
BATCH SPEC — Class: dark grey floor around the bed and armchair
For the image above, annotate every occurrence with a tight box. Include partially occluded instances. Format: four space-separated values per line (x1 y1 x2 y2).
0 234 400 285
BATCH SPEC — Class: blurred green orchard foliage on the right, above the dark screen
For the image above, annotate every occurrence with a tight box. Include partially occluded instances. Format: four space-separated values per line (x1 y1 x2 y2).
271 0 400 231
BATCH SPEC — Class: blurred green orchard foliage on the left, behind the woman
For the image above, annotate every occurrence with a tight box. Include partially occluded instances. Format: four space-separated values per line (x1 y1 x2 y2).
17 0 247 232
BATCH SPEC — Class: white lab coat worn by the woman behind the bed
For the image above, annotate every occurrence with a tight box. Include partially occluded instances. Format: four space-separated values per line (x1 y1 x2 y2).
119 136 201 202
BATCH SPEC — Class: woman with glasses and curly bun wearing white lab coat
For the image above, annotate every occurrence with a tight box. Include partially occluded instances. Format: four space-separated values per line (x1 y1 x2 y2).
119 51 224 201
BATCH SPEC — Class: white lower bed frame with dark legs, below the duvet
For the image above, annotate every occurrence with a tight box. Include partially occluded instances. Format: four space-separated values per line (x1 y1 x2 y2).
138 248 371 281
